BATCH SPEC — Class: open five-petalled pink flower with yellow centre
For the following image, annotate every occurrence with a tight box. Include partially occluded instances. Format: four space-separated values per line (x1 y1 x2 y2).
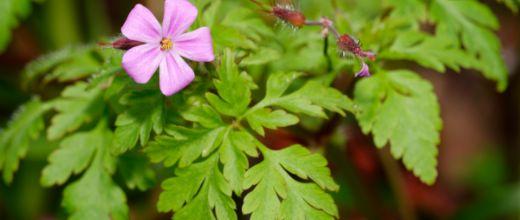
121 0 215 96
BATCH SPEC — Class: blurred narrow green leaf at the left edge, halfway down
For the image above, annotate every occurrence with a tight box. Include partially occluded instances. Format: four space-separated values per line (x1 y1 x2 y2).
0 98 49 183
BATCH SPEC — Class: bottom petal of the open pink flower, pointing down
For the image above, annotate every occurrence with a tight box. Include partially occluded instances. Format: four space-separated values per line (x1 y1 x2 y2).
159 53 195 96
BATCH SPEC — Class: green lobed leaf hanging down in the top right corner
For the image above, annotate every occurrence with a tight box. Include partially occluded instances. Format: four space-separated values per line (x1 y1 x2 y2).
430 0 508 91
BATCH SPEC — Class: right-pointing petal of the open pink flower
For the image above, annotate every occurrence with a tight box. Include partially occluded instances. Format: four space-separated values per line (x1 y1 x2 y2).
174 27 215 62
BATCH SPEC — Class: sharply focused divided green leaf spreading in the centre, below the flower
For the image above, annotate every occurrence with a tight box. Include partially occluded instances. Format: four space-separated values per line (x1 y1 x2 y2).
145 51 342 219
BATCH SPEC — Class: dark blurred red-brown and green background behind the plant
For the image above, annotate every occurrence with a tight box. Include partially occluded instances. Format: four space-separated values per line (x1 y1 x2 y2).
0 0 520 219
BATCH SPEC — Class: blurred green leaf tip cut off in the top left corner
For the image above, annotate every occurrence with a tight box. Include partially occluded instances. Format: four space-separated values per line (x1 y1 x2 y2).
0 0 31 53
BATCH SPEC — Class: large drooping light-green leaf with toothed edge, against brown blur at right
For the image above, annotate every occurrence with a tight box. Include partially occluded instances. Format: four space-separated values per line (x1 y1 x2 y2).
354 70 442 184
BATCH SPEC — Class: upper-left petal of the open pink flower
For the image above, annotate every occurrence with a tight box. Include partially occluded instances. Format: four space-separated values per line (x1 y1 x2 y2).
121 4 162 43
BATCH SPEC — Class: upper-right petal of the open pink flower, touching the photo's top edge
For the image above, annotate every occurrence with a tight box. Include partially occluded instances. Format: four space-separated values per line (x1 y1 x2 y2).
162 0 198 39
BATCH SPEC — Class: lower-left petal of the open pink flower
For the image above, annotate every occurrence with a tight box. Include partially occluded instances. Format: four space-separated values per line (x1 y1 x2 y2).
123 44 164 83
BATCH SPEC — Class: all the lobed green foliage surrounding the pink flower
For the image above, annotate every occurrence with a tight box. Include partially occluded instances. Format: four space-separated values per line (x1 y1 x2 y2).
0 0 518 220
